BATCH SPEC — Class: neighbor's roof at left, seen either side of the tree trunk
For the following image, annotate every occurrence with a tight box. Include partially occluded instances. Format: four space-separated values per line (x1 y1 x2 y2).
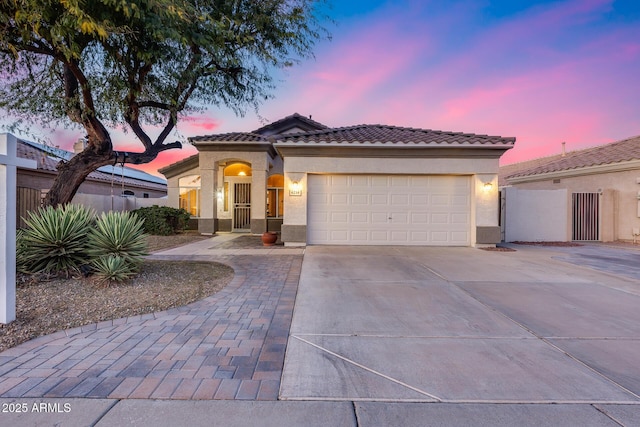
17 139 167 190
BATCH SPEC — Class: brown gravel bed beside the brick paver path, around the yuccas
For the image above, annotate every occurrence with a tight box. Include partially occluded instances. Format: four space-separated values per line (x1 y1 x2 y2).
0 234 233 351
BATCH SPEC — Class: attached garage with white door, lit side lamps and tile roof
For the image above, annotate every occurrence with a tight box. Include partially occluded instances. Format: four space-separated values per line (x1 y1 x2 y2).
273 125 515 246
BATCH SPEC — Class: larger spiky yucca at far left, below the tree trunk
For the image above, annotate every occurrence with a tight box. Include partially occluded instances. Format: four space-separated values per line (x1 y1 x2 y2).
17 204 94 274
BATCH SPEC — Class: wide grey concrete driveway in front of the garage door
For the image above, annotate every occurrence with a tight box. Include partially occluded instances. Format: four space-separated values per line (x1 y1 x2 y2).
280 246 640 408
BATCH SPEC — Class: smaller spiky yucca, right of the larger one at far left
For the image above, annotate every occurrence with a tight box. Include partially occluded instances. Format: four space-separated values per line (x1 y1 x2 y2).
88 212 147 267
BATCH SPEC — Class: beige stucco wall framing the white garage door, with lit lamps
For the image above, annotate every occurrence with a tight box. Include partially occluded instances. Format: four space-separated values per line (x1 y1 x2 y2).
283 156 499 245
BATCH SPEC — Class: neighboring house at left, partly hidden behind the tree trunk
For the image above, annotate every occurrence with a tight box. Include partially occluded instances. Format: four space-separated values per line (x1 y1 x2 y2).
17 139 167 226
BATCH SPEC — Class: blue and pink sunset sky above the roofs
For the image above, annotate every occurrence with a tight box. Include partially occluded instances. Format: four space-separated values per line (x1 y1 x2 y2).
2 0 640 174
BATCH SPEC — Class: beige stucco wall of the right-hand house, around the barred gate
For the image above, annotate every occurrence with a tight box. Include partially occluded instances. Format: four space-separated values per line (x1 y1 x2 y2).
513 169 640 242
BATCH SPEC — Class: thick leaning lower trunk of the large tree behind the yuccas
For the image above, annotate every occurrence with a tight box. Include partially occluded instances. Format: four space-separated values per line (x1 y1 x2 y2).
44 147 114 206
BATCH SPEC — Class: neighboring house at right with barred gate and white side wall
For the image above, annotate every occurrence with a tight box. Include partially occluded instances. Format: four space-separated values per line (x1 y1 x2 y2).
500 136 640 242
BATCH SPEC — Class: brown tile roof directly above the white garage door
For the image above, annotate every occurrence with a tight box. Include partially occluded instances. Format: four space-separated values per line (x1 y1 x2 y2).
276 125 515 148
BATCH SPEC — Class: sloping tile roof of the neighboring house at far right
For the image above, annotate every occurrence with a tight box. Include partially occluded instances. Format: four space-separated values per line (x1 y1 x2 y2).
505 135 640 180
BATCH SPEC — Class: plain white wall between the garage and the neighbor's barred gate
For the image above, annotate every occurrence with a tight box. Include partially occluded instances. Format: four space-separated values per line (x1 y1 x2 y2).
502 187 569 242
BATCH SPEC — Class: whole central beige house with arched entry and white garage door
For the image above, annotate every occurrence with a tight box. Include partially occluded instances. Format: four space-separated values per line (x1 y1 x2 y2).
160 113 515 246
